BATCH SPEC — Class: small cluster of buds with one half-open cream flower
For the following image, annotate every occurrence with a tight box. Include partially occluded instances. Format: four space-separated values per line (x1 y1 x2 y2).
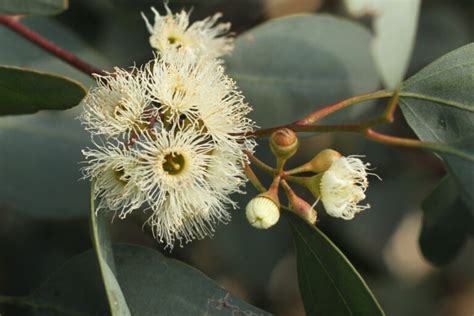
246 128 371 229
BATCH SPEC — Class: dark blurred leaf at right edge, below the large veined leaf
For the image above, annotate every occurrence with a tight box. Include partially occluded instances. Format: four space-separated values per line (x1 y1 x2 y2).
420 176 472 265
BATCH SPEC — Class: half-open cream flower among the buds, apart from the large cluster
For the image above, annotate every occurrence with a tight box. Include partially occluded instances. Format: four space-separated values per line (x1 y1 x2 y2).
320 156 370 220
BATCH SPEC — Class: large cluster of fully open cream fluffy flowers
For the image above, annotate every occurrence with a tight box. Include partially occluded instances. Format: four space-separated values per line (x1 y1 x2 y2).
81 4 255 248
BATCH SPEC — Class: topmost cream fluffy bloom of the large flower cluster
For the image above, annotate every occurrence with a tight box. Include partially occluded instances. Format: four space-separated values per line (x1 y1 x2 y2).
142 6 233 58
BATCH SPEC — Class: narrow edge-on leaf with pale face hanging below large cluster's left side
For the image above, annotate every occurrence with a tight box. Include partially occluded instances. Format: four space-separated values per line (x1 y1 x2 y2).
90 183 131 316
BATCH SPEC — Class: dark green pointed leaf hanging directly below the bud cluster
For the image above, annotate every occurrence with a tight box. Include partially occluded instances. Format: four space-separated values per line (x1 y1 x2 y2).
285 212 384 316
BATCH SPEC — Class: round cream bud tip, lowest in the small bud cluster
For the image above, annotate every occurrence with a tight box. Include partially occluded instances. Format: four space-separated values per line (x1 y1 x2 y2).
245 195 280 229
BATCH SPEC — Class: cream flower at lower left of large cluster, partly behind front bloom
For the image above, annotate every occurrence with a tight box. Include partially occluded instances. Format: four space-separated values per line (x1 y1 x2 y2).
82 143 147 218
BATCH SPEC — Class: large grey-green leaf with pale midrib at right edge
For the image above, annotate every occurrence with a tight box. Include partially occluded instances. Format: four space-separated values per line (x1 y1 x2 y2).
400 44 474 214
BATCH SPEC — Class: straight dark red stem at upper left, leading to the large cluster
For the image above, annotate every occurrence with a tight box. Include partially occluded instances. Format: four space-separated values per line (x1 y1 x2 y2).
0 16 105 76
